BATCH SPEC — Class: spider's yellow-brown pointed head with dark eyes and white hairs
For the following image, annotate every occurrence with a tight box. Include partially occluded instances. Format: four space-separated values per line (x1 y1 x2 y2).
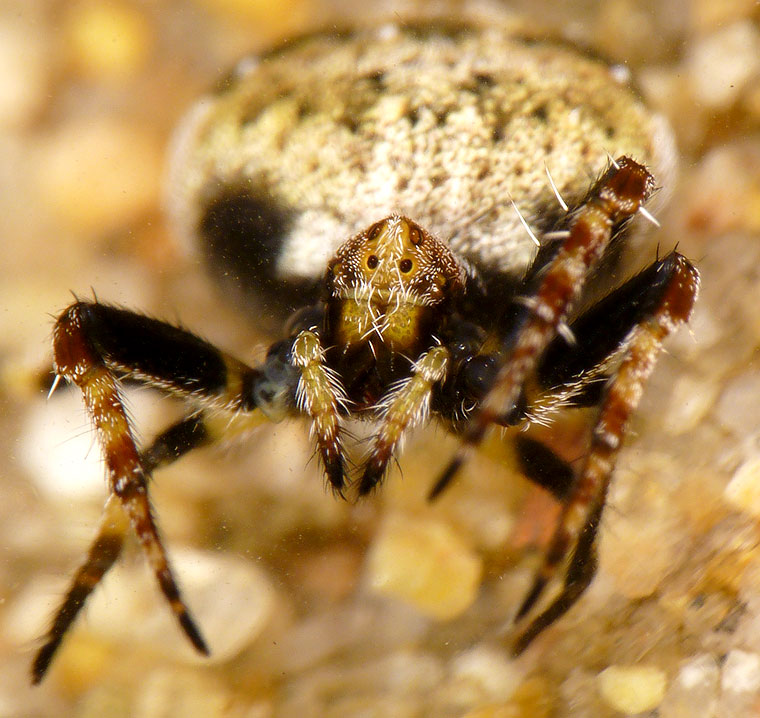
327 215 464 351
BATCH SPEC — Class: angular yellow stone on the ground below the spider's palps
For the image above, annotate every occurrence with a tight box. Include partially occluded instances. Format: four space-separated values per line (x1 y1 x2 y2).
368 514 483 620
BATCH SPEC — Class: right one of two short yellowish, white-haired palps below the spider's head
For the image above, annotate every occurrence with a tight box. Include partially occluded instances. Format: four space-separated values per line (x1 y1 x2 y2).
359 346 450 496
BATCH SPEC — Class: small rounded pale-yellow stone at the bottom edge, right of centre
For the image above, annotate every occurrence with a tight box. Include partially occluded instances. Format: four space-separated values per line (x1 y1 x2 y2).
598 665 667 715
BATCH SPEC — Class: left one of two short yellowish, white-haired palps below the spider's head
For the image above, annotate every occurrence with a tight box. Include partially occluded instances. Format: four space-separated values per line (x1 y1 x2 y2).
291 329 348 495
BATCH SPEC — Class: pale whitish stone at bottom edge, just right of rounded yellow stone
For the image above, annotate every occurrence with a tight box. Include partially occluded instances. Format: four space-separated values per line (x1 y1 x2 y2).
659 653 720 718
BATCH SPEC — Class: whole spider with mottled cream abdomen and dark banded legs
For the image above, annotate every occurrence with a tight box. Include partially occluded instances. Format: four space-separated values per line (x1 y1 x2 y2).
32 23 699 683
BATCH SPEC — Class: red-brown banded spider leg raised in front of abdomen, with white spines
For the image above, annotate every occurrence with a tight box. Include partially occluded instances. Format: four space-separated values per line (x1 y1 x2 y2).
430 157 654 499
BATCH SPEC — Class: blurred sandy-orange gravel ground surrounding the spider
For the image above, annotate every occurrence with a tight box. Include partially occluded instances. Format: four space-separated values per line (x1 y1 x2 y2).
0 0 760 718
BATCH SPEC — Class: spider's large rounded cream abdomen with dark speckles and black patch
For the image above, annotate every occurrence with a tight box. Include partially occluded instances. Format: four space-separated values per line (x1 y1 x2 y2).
169 23 674 324
